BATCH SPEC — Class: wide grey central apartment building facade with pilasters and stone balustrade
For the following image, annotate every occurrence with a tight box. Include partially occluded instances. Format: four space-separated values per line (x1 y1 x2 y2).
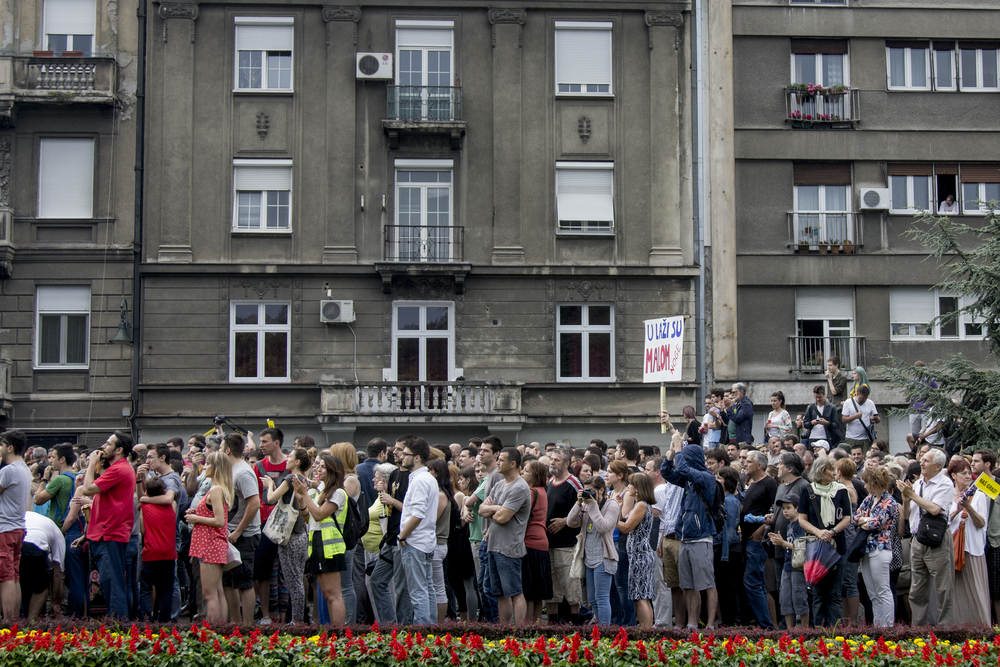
136 2 700 446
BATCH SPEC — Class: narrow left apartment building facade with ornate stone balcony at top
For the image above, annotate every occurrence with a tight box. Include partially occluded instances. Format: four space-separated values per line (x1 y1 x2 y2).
0 0 138 445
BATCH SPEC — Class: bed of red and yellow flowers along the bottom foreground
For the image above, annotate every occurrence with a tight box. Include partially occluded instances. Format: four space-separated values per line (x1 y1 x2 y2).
0 625 1000 667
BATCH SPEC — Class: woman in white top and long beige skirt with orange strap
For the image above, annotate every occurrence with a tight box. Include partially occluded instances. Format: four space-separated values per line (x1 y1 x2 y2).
948 456 990 625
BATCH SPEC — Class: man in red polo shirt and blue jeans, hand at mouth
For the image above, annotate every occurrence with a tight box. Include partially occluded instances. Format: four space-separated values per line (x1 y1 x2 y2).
81 431 135 620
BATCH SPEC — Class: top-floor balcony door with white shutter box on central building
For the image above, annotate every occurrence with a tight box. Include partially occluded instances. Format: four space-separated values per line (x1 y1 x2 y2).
396 21 454 120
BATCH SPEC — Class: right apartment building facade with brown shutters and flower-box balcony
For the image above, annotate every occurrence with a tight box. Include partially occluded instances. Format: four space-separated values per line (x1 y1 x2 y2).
708 0 1000 451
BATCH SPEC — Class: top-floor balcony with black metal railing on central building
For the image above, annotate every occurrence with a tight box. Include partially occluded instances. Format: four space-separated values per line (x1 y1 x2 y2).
382 86 466 150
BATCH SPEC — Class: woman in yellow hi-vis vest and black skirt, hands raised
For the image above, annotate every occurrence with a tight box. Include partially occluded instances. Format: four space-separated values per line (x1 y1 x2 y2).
292 454 350 625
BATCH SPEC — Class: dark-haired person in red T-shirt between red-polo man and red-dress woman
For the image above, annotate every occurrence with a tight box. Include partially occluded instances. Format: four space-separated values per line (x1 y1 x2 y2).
136 477 177 623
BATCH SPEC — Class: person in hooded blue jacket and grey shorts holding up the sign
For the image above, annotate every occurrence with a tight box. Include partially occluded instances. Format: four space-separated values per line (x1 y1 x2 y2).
660 413 719 629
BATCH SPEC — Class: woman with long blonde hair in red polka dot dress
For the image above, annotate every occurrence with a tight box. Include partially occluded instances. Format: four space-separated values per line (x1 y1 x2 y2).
184 452 233 621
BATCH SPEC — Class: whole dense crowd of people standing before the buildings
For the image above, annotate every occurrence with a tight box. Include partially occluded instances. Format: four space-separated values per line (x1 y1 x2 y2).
0 360 1000 629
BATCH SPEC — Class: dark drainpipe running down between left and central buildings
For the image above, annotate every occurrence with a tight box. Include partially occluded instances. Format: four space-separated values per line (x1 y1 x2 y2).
129 0 148 442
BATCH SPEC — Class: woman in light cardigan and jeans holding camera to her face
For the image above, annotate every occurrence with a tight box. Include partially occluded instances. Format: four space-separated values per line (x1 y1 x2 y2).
566 475 621 625
